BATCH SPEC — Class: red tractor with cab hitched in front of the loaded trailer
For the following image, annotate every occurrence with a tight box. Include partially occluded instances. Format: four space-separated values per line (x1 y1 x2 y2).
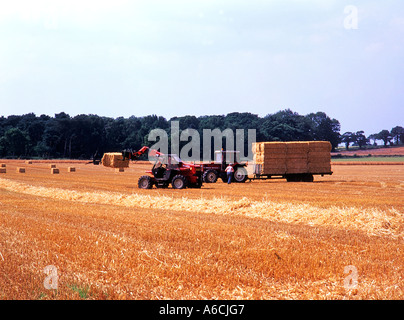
201 150 248 183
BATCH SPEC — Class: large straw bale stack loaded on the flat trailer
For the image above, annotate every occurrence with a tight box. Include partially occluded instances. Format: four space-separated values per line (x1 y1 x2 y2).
253 141 332 181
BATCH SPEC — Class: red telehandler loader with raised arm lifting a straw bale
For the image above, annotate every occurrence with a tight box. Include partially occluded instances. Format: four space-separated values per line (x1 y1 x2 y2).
122 147 202 189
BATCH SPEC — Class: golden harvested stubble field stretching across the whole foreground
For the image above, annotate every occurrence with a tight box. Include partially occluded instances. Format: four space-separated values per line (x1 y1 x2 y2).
0 160 404 299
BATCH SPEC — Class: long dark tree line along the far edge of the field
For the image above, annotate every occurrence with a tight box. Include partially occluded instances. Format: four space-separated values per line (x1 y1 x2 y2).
0 109 404 159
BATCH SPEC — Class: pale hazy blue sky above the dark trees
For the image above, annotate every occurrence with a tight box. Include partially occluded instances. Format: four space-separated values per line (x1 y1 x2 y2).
0 0 404 135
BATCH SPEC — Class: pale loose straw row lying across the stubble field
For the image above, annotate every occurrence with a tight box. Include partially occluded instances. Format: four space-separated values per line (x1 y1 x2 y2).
0 178 404 238
